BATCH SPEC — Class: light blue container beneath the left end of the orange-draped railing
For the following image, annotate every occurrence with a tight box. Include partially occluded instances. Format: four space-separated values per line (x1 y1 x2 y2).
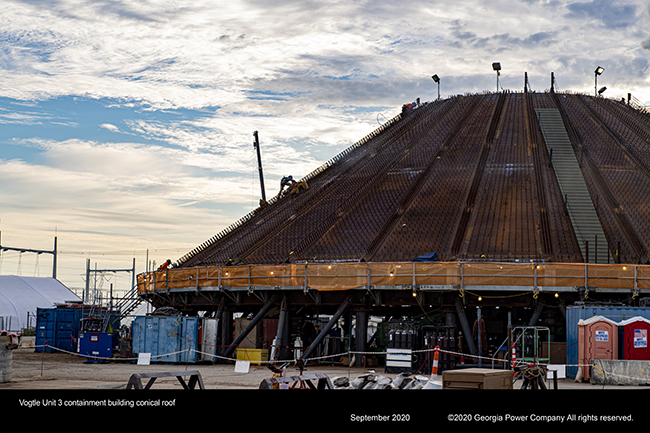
132 316 199 363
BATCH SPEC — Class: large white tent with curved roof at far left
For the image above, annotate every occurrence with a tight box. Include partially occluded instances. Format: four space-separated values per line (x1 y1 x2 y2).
0 275 81 332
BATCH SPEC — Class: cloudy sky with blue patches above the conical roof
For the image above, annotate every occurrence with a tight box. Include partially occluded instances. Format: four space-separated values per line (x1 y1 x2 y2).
0 0 650 296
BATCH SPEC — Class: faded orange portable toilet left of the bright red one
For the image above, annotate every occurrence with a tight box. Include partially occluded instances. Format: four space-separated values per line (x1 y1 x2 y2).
578 316 618 381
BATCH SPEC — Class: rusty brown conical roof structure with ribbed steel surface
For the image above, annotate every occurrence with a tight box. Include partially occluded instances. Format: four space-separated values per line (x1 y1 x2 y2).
174 92 650 268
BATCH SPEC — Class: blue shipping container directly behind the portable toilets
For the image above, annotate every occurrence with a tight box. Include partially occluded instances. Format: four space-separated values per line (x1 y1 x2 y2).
566 305 650 379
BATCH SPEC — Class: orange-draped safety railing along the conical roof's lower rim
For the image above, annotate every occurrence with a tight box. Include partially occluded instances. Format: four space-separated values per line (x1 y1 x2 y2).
137 262 650 294
